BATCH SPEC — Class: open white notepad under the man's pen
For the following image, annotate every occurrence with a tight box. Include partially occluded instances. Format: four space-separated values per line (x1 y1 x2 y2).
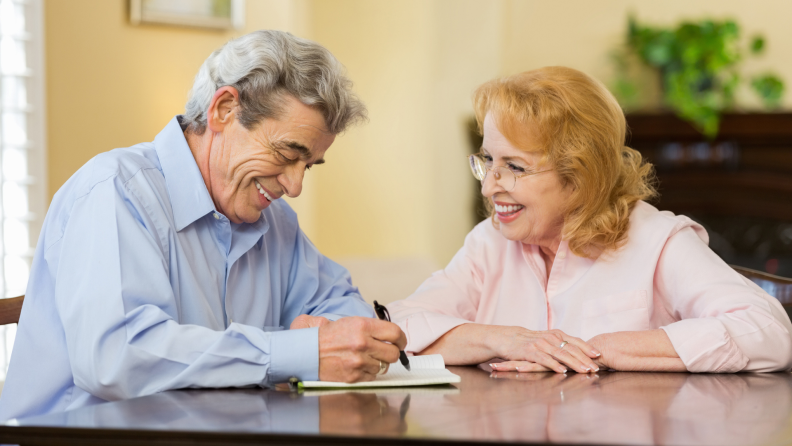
300 355 462 389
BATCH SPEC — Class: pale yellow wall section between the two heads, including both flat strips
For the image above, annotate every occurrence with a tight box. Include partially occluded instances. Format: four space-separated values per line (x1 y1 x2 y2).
304 0 500 264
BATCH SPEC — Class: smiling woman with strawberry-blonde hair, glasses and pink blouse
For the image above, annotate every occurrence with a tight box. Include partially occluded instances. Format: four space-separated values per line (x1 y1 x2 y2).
390 67 792 373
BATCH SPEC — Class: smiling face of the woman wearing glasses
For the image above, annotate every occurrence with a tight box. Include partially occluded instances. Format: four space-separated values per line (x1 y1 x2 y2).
481 114 571 249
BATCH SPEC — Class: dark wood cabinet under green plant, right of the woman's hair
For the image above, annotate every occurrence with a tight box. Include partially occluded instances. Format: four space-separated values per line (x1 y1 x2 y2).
626 113 792 275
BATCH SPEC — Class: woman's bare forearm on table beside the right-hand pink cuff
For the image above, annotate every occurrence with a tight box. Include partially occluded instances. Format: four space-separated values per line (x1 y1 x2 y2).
588 329 687 372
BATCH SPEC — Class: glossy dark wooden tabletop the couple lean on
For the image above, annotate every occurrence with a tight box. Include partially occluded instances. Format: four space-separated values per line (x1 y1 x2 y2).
0 367 792 446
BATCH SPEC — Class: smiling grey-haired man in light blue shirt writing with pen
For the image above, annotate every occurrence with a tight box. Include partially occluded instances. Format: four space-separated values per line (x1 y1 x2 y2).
0 31 406 419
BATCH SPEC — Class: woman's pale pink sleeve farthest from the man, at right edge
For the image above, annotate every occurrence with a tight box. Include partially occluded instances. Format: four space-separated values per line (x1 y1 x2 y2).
655 227 792 372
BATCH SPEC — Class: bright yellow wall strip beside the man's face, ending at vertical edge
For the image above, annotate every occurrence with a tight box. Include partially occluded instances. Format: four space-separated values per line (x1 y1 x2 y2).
310 0 433 256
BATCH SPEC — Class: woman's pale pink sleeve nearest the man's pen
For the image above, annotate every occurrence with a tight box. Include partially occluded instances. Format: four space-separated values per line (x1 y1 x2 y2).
388 228 483 353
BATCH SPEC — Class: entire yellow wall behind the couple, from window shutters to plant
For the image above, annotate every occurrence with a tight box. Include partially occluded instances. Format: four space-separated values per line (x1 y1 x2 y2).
45 0 792 264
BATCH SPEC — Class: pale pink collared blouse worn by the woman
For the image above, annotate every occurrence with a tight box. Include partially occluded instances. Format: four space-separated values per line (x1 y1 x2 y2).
388 202 792 372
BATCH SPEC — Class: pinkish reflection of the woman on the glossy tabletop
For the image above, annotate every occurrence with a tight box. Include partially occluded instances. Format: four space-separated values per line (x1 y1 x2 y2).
418 369 792 445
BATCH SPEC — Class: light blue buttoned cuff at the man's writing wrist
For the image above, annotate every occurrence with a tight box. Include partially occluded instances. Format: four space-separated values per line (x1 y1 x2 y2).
267 327 319 383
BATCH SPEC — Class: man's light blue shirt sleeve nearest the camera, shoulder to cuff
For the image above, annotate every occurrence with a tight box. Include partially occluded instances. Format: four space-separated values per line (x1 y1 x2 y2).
47 178 318 400
